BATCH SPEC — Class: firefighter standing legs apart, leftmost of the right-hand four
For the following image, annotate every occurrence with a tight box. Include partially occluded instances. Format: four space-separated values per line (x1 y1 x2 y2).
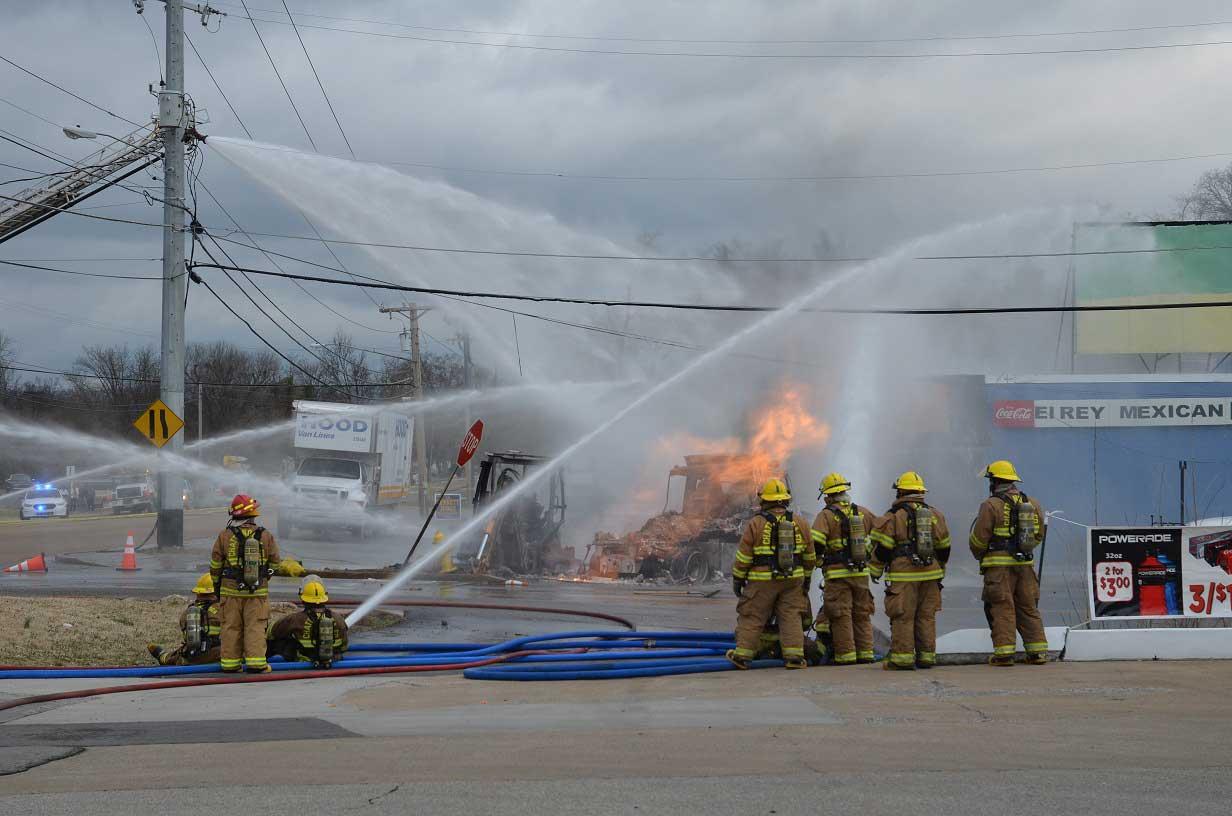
727 478 817 668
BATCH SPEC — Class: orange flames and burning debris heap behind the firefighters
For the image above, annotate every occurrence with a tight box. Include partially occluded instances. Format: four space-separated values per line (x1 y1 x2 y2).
584 390 829 583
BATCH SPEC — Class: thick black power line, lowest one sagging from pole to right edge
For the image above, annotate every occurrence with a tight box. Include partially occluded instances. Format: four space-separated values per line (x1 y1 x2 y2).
190 258 1232 316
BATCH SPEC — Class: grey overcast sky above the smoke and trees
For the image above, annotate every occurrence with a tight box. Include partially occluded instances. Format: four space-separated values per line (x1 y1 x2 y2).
0 0 1232 367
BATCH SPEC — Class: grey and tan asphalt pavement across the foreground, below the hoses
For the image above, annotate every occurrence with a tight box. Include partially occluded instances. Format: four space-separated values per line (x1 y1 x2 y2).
0 662 1232 816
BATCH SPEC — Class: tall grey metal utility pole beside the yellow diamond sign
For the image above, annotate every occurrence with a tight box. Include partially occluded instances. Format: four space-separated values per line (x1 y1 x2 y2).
158 0 187 550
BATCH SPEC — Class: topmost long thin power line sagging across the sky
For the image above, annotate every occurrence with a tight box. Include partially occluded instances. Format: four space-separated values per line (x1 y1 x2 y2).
218 2 1232 46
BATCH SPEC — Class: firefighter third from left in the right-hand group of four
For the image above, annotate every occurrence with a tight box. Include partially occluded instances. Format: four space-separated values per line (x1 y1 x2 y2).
870 471 950 671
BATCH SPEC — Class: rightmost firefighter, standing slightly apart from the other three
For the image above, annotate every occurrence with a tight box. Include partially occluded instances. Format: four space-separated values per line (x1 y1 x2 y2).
971 460 1048 666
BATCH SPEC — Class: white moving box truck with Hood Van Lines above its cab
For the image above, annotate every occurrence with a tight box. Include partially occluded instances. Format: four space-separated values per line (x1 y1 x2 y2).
277 399 414 537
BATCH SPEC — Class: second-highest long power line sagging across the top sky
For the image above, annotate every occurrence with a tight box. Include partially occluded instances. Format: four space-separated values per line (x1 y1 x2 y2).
224 16 1232 60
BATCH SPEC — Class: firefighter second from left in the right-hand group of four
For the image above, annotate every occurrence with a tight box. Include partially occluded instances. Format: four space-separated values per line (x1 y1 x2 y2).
813 473 877 666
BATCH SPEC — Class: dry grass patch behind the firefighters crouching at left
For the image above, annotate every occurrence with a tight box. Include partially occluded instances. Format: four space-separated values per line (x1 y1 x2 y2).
0 595 402 666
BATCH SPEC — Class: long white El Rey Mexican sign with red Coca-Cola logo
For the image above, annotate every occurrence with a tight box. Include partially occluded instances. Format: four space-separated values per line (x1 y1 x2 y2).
993 397 1232 428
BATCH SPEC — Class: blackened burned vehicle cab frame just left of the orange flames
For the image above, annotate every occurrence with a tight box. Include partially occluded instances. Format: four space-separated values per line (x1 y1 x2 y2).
453 451 573 574
